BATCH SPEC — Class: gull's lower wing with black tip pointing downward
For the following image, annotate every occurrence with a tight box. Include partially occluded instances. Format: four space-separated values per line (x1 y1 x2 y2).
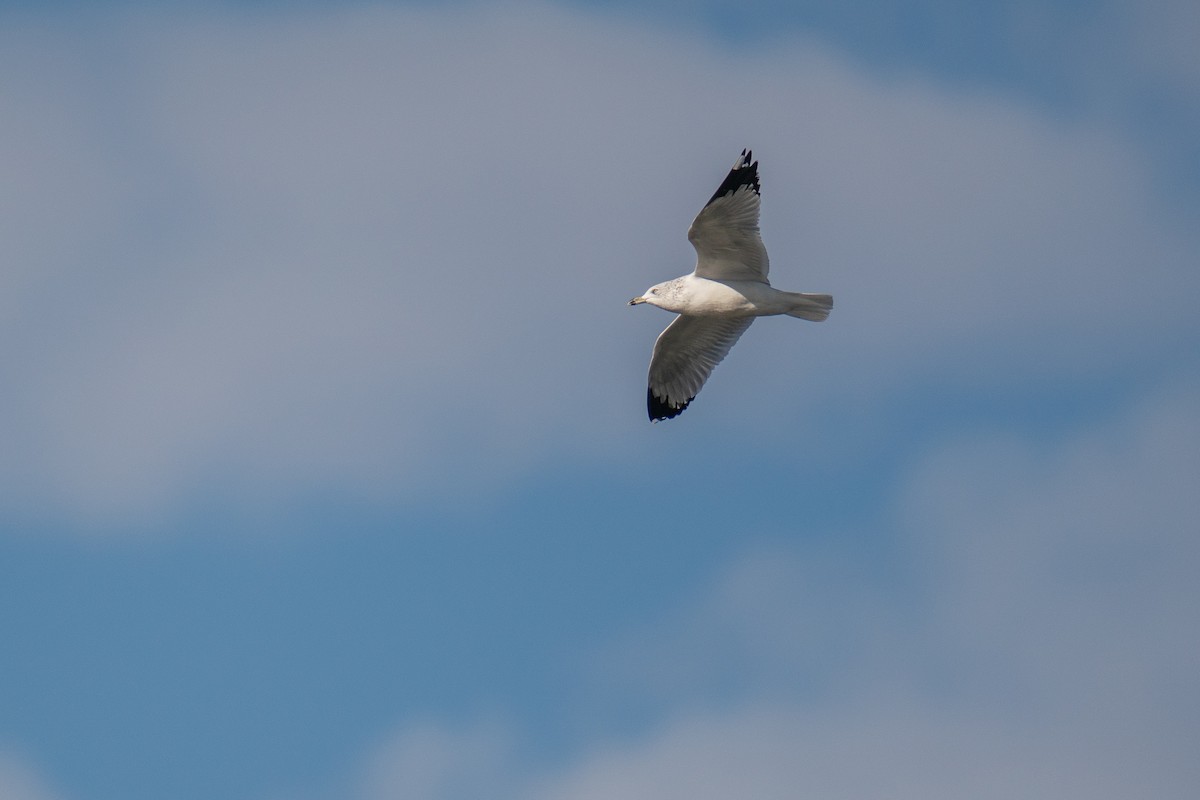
646 315 755 422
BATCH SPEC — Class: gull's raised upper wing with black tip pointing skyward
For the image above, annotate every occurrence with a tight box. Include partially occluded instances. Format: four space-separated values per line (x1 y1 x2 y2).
688 150 768 283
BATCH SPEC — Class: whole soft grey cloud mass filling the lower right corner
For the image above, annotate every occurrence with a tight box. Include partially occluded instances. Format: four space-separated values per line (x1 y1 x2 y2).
533 385 1200 800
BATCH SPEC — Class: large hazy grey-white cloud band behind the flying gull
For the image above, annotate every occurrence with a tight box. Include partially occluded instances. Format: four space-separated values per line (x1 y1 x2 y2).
0 6 1198 528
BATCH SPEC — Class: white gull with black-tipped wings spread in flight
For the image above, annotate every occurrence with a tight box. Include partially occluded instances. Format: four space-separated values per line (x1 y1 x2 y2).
629 150 833 422
